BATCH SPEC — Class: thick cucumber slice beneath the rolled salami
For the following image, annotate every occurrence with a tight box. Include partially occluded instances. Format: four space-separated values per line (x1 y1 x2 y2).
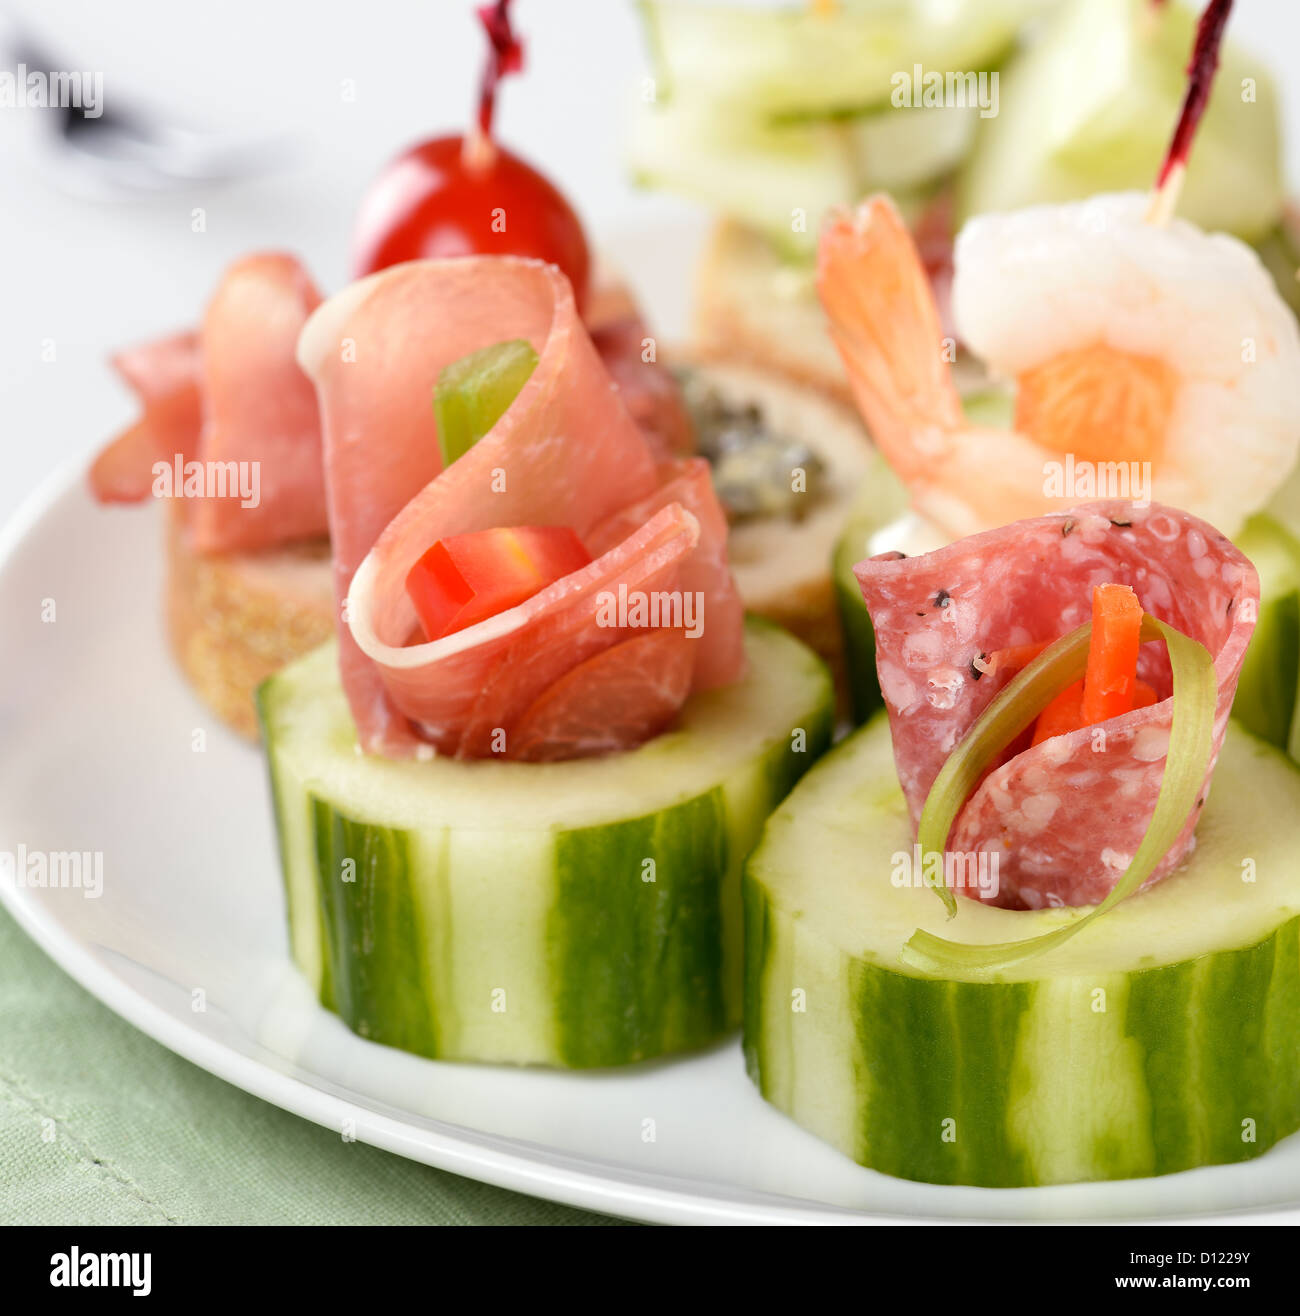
745 715 1300 1187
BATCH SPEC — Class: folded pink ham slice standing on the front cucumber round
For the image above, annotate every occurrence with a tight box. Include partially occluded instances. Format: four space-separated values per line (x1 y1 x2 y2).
299 257 742 758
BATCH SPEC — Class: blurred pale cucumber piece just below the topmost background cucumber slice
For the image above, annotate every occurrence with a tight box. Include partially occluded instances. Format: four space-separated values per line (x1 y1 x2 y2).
629 97 978 258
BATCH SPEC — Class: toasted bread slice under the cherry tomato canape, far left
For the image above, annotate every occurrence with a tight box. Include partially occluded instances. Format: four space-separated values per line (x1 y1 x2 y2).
166 503 334 740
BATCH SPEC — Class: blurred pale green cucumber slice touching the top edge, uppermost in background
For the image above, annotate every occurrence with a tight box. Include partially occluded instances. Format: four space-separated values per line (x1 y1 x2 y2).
641 0 1045 117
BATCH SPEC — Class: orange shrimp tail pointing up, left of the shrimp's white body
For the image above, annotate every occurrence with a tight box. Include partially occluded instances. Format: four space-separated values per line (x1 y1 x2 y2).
817 195 963 480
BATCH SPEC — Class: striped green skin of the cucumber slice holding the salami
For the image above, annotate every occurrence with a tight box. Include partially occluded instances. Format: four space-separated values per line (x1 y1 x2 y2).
745 876 1300 1188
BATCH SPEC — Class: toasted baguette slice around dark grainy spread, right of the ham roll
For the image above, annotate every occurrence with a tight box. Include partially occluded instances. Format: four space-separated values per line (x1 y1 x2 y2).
684 350 872 670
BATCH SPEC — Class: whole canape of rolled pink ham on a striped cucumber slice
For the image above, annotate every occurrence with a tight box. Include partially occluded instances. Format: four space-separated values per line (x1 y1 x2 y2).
259 258 833 1067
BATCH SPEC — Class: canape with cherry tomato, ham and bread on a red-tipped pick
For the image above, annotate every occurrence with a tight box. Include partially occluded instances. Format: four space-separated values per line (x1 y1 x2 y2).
91 0 691 737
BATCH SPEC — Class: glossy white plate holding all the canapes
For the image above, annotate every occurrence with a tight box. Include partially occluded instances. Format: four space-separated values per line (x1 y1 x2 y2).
0 472 1300 1223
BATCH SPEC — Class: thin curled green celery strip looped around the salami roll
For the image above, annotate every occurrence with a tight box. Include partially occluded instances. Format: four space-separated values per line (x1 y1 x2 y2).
903 613 1217 974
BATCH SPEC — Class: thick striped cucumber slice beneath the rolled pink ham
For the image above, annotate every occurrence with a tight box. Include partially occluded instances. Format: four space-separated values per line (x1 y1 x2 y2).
259 620 833 1066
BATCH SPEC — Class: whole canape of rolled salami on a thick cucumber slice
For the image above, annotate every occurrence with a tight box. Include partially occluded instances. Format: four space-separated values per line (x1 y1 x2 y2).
745 501 1300 1187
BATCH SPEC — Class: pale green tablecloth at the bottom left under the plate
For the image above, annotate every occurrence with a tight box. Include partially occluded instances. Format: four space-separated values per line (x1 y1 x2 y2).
0 911 613 1225
